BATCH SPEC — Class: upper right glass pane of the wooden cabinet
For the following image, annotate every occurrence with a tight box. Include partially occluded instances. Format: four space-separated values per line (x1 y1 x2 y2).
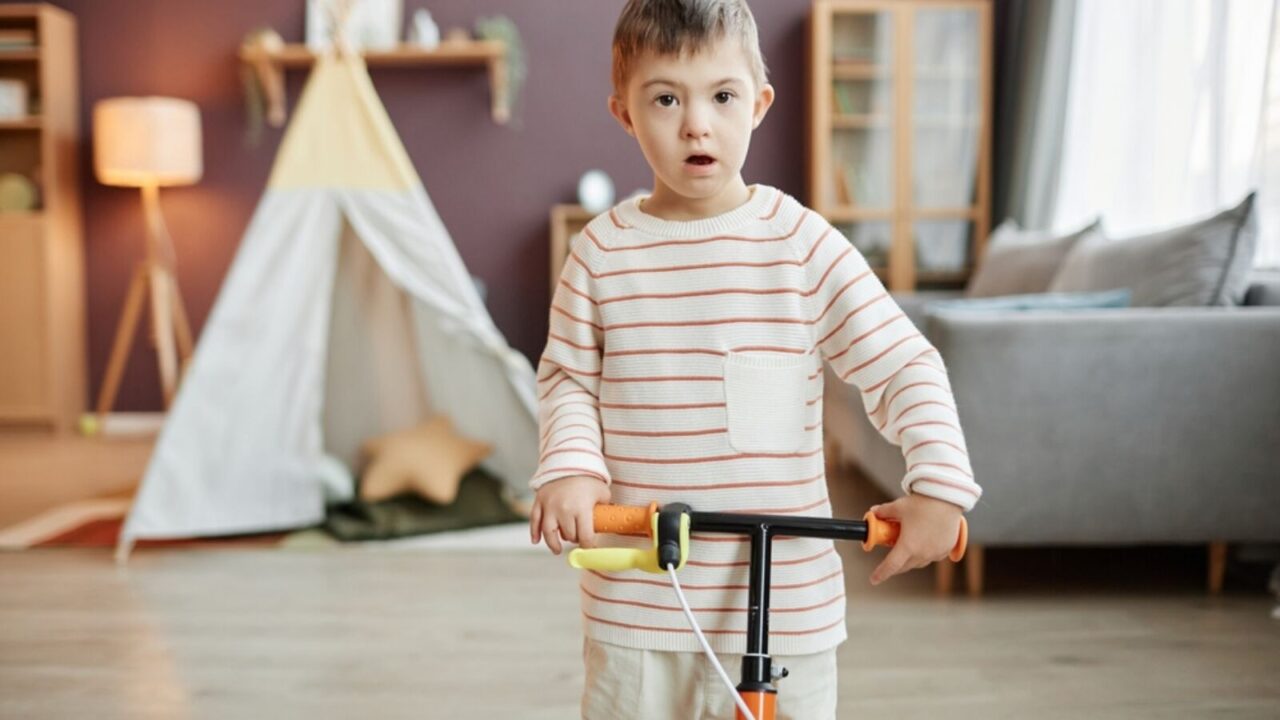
911 9 982 208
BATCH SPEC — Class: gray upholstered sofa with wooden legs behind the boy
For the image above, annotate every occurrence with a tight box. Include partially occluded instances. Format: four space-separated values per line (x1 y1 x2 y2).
824 274 1280 593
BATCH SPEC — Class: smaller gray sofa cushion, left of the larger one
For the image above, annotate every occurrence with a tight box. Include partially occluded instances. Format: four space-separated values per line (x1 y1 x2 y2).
965 219 1101 297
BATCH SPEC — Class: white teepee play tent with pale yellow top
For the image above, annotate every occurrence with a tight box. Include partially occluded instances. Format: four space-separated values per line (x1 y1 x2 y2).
119 55 538 557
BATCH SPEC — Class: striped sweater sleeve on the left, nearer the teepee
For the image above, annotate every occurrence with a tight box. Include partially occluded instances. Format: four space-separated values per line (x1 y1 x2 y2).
529 236 611 489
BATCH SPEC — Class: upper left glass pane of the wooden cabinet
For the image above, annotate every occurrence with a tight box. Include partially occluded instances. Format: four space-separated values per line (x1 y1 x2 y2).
826 13 893 208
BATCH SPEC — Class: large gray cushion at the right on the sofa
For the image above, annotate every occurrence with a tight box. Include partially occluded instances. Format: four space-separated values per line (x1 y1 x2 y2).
1050 192 1258 307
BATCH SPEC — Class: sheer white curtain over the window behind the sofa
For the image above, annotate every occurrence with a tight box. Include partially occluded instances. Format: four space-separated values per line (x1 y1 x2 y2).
1052 0 1277 266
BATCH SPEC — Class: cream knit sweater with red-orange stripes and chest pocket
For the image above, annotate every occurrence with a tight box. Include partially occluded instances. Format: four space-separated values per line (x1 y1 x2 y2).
531 186 980 655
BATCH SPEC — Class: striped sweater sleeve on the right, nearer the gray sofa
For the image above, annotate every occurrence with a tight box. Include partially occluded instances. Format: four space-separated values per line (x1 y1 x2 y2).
804 225 982 511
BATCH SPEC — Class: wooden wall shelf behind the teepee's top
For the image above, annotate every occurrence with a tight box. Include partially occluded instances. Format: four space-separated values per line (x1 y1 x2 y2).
239 40 511 127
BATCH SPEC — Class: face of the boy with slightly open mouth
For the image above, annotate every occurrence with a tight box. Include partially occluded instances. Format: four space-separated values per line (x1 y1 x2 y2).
609 38 773 208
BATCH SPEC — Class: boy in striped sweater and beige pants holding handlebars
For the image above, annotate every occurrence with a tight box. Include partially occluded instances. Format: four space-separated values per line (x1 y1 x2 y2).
530 0 980 720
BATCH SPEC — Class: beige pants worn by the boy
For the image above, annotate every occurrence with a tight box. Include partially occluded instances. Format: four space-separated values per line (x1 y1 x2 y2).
582 639 836 720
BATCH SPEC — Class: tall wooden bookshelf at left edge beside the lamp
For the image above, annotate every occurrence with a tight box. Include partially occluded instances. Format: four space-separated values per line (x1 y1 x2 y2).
0 4 87 436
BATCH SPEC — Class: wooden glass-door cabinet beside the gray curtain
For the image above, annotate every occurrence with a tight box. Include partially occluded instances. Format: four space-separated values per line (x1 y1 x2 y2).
808 0 992 291
